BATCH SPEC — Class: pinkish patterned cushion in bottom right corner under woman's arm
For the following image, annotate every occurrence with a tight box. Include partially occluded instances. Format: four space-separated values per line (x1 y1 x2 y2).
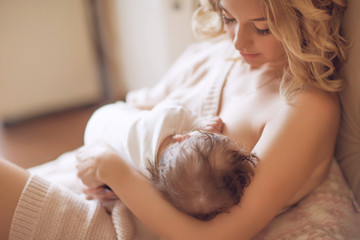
252 161 360 240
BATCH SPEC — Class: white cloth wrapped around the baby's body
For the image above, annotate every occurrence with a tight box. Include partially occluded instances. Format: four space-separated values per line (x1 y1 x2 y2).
84 101 198 176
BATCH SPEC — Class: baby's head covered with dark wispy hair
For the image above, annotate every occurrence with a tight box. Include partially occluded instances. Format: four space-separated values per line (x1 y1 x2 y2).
148 131 257 221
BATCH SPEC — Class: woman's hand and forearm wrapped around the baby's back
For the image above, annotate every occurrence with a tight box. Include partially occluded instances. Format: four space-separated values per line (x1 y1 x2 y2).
77 142 205 239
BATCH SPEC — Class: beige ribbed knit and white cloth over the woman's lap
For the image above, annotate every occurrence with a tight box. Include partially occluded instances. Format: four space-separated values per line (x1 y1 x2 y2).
10 151 159 240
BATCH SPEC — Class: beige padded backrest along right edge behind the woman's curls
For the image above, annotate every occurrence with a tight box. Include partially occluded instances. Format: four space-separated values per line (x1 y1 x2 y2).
335 0 360 202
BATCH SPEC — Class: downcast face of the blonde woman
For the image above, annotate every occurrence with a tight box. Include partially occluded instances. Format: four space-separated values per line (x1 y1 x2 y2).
220 0 285 68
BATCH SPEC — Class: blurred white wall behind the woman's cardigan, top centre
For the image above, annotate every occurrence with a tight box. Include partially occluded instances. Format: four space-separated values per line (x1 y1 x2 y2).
116 0 196 91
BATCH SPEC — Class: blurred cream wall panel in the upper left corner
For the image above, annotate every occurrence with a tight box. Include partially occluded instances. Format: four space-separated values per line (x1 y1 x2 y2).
0 0 102 121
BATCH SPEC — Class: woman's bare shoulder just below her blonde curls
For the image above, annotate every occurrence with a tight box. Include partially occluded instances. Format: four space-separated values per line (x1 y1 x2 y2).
264 89 340 154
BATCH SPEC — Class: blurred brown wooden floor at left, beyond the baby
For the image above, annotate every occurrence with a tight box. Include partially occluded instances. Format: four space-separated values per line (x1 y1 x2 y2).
0 105 99 168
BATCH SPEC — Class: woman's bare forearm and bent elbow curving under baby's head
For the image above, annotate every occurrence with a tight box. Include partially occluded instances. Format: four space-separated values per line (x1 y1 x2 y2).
94 144 274 240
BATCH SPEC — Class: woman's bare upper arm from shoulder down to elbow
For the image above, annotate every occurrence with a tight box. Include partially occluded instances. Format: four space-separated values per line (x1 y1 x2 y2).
225 90 340 235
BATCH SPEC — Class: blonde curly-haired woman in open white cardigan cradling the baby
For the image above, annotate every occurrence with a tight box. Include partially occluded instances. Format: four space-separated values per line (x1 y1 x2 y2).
0 0 354 239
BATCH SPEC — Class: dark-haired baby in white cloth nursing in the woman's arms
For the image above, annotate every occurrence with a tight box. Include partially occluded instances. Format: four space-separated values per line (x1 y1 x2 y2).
85 102 256 220
